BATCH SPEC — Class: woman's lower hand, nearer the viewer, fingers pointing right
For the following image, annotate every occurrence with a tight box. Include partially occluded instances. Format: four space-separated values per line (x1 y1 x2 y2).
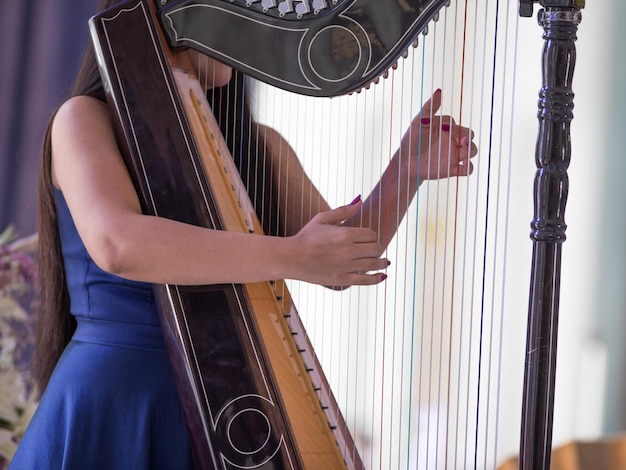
289 197 389 287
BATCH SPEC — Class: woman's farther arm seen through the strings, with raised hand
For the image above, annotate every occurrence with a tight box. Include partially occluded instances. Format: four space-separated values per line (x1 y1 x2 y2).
261 90 477 244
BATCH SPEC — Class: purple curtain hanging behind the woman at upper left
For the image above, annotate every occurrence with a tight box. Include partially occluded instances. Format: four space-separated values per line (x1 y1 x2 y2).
0 0 97 235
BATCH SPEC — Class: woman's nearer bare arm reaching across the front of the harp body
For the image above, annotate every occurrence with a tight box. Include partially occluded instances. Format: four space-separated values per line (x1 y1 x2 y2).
52 97 387 285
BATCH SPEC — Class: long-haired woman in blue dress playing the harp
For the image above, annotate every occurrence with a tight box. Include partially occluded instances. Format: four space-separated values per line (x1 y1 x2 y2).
12 0 477 469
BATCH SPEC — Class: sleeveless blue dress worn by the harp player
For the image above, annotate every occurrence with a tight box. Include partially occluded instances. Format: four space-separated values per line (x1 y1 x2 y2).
10 190 194 470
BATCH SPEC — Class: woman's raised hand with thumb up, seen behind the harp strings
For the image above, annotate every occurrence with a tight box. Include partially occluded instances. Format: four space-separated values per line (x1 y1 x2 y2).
400 90 478 183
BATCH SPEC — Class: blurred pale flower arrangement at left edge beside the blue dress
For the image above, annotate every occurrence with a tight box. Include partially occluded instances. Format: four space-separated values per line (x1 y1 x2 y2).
0 226 38 468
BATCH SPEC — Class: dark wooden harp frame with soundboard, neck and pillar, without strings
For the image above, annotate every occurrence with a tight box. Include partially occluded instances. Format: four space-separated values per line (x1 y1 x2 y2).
90 0 580 469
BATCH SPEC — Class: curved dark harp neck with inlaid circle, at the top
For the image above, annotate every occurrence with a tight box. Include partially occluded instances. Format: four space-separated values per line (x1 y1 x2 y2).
159 0 446 96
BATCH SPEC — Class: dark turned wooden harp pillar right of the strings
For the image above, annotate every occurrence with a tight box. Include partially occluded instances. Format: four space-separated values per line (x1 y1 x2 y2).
519 0 584 470
